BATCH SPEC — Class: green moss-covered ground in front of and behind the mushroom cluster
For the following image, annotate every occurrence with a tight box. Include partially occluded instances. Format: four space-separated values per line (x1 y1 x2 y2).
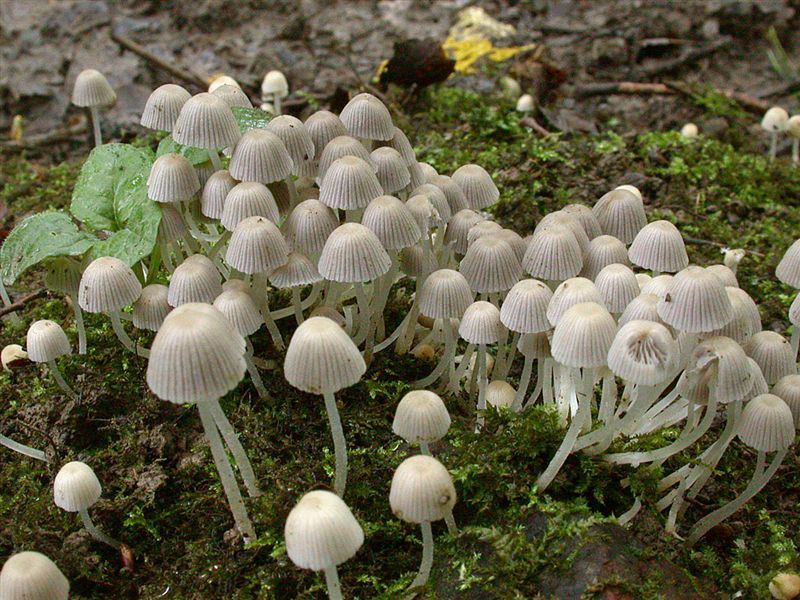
0 87 800 598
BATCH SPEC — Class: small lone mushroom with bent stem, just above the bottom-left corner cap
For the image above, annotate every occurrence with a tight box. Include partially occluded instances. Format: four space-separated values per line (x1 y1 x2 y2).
53 461 121 548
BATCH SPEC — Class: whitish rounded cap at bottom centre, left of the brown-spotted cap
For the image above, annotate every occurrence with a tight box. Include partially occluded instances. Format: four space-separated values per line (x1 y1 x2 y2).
283 490 364 571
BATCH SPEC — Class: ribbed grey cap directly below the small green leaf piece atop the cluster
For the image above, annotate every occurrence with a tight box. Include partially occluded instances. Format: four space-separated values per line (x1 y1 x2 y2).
228 129 293 183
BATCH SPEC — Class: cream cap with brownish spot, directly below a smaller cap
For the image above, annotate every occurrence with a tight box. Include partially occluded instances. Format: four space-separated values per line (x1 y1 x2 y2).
389 455 456 523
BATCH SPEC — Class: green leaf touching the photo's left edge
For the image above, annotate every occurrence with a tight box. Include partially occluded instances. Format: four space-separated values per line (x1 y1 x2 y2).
0 211 96 285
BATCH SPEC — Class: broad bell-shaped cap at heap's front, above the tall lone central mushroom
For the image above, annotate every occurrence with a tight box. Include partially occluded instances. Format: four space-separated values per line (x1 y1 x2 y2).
317 223 392 283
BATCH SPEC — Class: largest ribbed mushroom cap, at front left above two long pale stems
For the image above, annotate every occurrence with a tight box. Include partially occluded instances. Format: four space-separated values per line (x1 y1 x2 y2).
147 304 246 404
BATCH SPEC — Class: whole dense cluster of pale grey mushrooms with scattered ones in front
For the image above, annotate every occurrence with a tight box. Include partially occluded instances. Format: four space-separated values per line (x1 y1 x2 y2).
0 72 800 599
